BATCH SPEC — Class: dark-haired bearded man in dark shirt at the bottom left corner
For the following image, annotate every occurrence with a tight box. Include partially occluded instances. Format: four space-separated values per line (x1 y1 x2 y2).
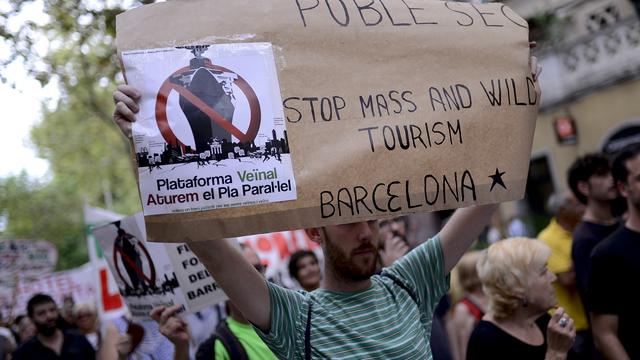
13 294 95 360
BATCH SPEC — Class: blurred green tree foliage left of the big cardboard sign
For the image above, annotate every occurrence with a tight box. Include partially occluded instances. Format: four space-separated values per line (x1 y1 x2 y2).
0 0 151 268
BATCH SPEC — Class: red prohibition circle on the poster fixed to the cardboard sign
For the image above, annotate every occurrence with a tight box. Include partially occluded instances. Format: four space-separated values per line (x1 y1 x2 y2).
156 60 261 151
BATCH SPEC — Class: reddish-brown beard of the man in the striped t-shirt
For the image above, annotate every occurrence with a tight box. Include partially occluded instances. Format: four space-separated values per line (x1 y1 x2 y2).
322 228 379 281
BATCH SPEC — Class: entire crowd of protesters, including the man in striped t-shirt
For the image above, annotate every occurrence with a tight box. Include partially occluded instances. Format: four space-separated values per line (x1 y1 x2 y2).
0 52 640 360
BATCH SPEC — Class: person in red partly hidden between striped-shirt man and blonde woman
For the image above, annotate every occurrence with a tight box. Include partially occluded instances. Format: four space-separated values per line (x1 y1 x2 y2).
449 251 487 360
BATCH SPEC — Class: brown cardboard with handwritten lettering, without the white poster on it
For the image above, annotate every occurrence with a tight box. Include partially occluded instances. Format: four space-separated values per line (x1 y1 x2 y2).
117 0 539 241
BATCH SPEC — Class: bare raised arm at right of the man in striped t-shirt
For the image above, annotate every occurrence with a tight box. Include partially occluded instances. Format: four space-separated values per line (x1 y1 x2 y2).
440 204 498 273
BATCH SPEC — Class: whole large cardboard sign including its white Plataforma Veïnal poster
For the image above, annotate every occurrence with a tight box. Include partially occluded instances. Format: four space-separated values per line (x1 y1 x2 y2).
117 0 539 241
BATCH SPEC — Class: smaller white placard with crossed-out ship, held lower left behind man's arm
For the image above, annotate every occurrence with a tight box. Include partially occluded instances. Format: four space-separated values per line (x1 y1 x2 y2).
93 213 226 319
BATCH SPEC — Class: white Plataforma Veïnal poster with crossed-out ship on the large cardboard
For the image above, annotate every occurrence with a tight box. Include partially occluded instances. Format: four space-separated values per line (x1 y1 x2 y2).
122 43 296 215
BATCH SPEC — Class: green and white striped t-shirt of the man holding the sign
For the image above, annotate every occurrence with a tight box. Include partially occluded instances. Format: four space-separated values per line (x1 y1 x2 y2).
256 236 449 359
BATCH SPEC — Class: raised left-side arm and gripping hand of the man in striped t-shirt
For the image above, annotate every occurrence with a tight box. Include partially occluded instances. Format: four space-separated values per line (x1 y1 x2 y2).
113 85 271 332
